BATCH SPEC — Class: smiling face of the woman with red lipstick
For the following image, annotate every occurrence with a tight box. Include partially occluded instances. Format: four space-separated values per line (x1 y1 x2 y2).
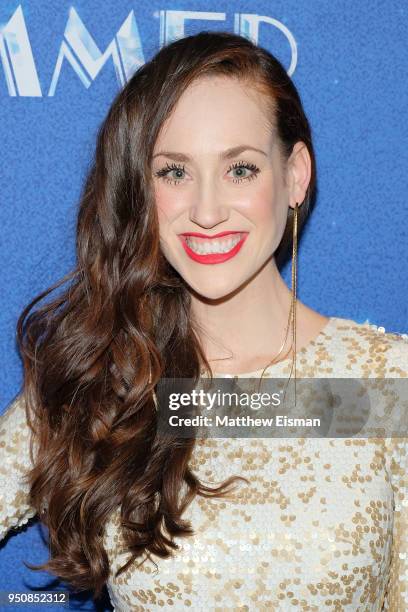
152 76 301 299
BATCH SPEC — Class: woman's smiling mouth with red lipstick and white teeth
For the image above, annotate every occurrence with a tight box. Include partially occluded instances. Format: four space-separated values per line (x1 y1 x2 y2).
179 232 248 264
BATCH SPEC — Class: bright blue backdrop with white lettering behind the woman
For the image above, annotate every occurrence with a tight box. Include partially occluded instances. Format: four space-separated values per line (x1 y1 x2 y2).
0 0 408 610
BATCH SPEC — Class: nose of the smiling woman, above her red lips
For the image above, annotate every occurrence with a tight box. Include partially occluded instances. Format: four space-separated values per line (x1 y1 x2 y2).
189 177 230 229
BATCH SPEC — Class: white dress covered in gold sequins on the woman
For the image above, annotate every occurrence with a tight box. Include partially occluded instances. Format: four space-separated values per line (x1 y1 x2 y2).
0 317 408 612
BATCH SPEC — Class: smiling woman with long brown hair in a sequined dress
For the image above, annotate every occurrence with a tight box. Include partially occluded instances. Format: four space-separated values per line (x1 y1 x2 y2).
0 32 408 611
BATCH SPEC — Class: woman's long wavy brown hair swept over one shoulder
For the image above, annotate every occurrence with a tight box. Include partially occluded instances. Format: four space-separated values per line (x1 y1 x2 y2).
17 31 315 599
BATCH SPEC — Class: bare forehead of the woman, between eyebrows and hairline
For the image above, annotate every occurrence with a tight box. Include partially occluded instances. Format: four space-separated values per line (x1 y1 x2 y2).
155 75 272 150
